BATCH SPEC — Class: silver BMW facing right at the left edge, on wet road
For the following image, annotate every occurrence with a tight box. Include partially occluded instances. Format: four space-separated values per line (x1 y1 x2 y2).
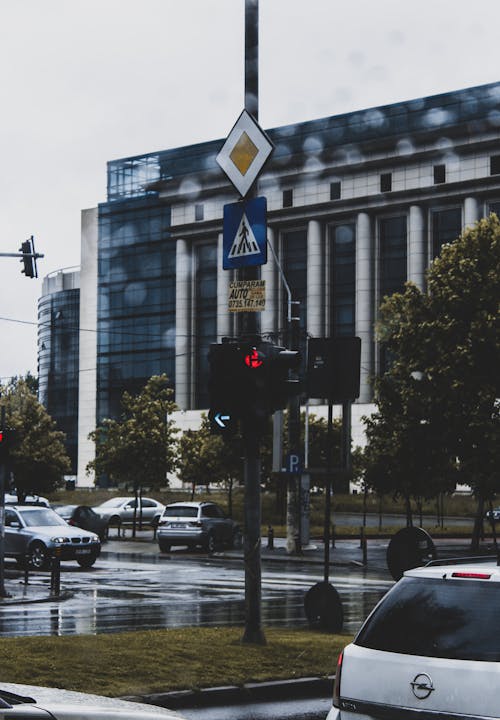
4 505 101 570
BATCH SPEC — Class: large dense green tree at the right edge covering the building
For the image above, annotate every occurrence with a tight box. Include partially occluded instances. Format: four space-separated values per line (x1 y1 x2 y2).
365 215 500 528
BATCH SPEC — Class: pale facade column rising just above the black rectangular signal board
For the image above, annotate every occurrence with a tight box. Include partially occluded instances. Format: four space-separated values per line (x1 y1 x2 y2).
307 220 325 337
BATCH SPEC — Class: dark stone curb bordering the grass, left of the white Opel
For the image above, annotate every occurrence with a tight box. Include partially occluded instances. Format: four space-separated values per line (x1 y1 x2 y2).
124 675 335 710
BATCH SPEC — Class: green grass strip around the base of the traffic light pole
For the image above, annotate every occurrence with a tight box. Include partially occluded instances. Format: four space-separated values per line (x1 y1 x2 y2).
0 627 351 697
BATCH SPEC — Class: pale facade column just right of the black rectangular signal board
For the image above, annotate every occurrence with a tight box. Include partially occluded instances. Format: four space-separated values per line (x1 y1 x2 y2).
356 213 374 403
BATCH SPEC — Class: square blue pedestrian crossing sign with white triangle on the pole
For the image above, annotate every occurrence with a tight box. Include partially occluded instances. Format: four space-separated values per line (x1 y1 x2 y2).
222 197 267 270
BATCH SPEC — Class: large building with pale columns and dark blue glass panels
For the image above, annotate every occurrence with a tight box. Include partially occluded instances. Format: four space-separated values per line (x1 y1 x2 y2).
39 83 500 484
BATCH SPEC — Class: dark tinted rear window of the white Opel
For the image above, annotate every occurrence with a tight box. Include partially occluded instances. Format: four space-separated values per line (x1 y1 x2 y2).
354 578 500 662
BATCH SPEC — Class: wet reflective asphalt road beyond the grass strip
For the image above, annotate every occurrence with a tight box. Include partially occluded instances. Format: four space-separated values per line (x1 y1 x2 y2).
0 543 393 637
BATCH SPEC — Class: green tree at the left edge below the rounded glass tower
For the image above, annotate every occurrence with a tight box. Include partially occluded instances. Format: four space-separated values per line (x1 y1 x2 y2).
0 375 71 501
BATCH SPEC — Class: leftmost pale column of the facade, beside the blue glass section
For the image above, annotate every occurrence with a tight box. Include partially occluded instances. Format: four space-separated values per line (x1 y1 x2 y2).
175 240 192 410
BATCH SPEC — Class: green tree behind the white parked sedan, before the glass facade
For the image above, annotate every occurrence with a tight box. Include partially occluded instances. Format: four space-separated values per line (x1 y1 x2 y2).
87 375 178 516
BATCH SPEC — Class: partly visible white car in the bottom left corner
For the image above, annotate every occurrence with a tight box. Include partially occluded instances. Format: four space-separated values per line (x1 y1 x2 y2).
0 683 186 720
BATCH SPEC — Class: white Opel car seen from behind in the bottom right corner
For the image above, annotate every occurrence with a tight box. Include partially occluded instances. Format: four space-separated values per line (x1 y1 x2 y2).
327 557 500 720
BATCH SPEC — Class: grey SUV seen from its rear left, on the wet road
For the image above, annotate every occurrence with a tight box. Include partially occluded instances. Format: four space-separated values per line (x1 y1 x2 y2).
158 502 242 552
